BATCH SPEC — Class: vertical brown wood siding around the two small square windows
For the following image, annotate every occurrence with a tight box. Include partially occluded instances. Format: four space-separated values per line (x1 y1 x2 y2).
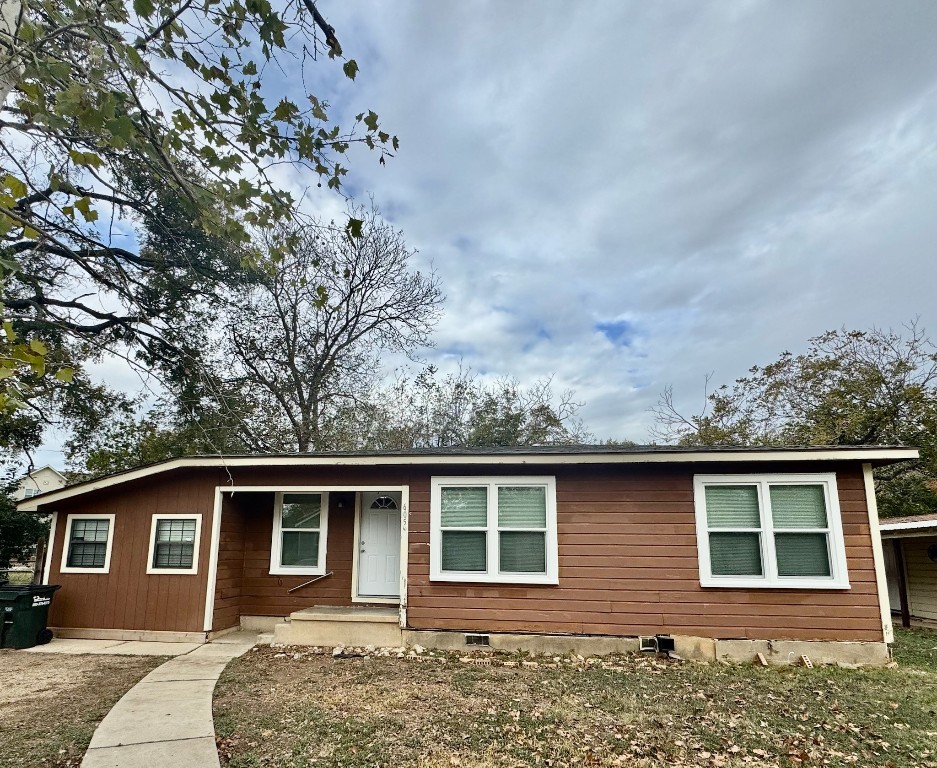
49 472 215 632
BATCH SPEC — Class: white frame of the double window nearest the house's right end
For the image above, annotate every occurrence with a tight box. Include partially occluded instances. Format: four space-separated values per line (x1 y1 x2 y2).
693 472 850 589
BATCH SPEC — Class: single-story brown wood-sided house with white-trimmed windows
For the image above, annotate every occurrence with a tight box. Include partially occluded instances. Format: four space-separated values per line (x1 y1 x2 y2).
20 446 918 663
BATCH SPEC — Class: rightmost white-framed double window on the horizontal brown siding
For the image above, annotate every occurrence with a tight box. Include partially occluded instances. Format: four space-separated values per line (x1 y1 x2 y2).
694 474 849 589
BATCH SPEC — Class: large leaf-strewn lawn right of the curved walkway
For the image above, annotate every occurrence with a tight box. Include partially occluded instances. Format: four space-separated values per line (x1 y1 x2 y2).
214 632 937 768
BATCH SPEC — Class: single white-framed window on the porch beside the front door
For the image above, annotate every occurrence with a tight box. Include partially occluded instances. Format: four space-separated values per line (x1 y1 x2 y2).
270 493 329 576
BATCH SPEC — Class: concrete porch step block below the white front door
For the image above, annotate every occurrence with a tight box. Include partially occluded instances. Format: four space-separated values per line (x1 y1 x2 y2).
272 606 403 648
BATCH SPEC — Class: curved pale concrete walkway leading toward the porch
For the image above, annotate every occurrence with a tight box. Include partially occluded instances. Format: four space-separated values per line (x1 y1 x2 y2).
81 632 257 768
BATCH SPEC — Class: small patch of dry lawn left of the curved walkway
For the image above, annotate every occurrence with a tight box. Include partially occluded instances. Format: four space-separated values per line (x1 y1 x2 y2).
0 651 166 768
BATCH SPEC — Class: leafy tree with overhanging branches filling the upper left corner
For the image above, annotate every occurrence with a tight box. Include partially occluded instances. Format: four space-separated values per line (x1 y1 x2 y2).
0 0 397 416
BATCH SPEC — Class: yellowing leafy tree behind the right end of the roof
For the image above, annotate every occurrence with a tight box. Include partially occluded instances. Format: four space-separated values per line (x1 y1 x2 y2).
653 322 937 516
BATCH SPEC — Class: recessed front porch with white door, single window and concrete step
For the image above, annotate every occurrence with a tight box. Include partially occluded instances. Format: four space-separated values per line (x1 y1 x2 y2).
212 485 407 645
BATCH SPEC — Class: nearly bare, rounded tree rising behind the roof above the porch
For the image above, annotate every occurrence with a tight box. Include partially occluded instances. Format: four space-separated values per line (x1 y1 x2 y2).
188 207 443 452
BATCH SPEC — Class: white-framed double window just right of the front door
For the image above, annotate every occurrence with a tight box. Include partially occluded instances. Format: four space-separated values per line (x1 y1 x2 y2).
430 477 559 584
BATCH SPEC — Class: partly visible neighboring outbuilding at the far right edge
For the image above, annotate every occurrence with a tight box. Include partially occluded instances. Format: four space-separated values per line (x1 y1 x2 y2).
879 514 937 628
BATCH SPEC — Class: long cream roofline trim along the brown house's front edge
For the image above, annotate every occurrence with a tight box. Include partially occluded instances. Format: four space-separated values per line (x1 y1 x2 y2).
18 447 919 511
